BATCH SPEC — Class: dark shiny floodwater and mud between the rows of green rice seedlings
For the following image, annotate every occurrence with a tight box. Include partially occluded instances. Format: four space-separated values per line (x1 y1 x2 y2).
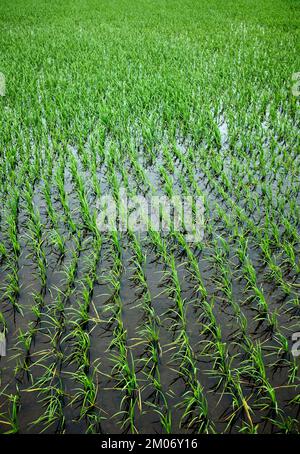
0 127 298 434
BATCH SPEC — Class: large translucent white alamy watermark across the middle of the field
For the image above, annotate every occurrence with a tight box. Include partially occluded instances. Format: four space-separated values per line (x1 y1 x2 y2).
97 188 204 242
